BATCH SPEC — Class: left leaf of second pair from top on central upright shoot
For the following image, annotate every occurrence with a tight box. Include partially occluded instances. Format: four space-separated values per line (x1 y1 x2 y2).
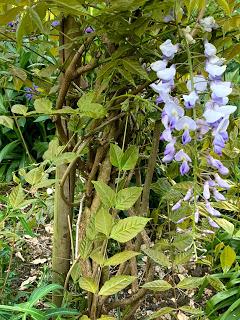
92 181 116 208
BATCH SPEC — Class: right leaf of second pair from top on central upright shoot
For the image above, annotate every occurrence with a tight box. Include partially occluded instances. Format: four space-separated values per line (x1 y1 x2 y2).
115 187 142 210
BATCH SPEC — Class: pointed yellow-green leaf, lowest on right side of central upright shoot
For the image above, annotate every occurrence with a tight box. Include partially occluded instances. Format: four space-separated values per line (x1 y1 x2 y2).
98 276 136 296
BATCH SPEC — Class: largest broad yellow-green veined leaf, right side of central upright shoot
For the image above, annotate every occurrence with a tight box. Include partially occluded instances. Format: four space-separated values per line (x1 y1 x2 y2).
110 217 150 243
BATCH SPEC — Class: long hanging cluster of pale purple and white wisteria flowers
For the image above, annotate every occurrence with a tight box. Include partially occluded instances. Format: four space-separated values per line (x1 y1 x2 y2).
150 40 236 232
